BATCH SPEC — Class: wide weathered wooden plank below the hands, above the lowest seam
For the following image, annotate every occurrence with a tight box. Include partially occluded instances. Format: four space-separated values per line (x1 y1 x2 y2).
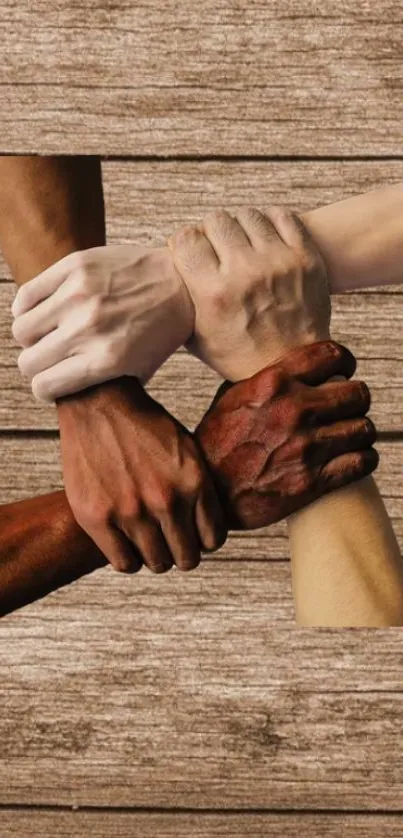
0 561 403 811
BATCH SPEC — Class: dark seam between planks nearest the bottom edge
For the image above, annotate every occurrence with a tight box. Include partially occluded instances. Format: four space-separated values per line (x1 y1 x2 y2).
0 803 403 818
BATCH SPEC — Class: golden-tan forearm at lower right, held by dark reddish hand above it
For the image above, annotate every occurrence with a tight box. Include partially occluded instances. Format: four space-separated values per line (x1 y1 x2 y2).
288 478 403 627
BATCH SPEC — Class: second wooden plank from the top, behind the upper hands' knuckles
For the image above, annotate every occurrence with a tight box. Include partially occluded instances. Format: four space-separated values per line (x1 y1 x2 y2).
0 161 403 282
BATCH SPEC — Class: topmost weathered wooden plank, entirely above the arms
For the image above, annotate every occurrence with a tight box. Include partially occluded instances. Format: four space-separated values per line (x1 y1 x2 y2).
0 0 403 156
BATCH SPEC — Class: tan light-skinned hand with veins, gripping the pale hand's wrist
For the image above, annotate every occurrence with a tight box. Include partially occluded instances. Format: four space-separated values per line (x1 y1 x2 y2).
168 207 330 381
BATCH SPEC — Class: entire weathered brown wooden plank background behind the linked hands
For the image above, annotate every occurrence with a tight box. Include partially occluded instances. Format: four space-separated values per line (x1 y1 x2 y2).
0 0 403 838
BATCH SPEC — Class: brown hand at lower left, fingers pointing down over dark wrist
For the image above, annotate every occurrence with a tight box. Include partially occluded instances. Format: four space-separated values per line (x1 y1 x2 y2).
58 378 226 573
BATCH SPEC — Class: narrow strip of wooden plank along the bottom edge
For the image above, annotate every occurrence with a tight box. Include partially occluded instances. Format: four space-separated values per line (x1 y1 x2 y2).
0 809 402 838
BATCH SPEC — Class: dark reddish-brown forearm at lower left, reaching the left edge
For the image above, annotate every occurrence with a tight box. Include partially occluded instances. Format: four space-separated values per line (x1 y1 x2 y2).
0 492 107 616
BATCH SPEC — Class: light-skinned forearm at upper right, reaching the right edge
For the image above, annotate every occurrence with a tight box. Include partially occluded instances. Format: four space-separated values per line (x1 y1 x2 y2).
301 183 403 294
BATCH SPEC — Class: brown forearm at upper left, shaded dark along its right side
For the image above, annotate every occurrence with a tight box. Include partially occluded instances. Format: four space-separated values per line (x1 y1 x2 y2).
0 155 105 285
